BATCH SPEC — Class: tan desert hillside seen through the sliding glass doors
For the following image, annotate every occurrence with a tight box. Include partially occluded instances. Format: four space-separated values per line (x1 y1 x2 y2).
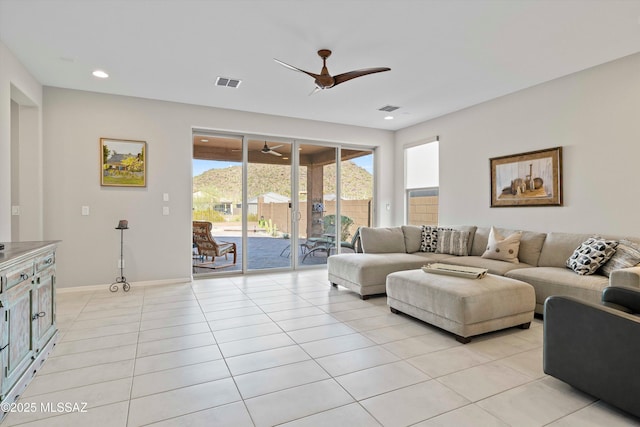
193 161 373 203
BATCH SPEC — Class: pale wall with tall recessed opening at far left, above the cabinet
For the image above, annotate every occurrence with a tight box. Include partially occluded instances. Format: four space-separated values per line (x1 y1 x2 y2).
0 41 43 242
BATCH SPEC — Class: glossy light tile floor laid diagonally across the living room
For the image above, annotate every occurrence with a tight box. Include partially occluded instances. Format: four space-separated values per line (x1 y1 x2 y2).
2 270 640 427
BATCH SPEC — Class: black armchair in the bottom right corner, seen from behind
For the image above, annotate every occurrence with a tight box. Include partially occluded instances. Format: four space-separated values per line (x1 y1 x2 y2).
544 287 640 417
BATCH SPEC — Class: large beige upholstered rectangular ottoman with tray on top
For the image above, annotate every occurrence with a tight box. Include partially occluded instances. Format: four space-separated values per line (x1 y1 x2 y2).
386 270 536 344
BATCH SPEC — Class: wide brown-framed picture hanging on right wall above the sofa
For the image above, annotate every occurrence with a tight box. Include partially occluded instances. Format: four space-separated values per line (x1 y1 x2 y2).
489 147 562 208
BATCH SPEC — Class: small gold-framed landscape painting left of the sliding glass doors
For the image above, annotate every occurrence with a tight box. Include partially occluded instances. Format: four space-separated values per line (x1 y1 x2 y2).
100 138 147 187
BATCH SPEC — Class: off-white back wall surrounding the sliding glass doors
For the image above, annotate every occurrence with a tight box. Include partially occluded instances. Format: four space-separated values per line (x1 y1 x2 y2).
44 87 393 287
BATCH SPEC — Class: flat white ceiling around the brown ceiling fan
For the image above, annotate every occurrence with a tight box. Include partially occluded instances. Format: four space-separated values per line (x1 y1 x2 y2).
0 0 640 130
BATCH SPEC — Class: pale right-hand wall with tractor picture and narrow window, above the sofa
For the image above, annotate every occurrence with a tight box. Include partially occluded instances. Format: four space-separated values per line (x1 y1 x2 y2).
394 54 640 237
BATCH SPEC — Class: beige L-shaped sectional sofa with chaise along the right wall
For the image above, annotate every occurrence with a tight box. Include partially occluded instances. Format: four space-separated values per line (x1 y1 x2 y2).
327 225 640 313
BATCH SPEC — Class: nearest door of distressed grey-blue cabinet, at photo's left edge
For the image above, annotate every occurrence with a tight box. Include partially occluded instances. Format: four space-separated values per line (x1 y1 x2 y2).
3 280 33 394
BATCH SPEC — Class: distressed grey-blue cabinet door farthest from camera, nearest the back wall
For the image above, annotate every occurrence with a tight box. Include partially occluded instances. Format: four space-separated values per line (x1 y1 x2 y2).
33 268 55 353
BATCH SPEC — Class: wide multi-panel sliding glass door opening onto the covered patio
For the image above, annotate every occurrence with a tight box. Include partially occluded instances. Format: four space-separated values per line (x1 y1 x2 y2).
192 132 373 276
